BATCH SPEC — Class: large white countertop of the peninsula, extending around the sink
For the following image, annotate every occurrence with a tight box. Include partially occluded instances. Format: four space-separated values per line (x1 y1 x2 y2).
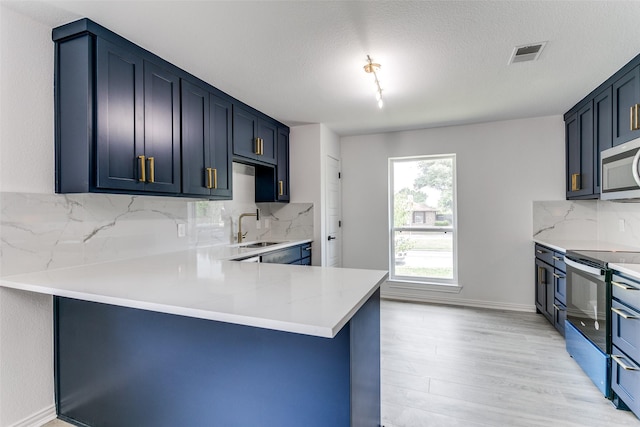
0 241 388 338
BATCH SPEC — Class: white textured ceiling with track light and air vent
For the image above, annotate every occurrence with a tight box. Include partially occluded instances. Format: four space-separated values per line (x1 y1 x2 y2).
2 0 640 135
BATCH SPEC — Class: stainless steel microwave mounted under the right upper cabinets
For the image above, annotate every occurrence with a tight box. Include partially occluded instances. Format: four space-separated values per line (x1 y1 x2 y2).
600 138 640 201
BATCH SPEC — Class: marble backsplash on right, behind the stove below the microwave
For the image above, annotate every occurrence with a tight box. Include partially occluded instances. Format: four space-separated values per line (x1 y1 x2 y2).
533 200 640 249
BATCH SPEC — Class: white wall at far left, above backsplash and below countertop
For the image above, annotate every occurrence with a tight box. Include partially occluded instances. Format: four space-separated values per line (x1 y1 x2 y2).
0 4 54 427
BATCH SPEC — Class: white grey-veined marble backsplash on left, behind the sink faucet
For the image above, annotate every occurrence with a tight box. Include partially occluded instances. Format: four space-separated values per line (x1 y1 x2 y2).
0 167 313 276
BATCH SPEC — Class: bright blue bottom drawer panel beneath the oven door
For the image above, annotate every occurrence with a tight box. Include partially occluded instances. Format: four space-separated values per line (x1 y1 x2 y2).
565 321 611 398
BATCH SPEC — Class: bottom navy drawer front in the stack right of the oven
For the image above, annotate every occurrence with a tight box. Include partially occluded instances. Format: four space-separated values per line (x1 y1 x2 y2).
611 345 640 416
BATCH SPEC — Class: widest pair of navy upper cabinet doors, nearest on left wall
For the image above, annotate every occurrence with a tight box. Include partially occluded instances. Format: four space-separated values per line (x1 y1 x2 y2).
96 38 180 193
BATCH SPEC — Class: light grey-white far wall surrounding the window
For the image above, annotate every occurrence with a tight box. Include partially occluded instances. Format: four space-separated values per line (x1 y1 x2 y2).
341 116 565 310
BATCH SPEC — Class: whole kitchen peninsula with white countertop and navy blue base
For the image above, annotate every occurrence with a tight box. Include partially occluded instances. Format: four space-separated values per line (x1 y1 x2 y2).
1 244 387 427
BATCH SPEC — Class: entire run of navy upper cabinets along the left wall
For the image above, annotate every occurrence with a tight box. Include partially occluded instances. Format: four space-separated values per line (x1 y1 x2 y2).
52 19 289 199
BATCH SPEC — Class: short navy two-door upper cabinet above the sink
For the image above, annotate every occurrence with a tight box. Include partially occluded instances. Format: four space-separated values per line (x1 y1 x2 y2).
233 103 278 165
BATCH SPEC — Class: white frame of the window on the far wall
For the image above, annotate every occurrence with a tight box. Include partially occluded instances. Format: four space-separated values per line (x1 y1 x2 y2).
388 153 458 286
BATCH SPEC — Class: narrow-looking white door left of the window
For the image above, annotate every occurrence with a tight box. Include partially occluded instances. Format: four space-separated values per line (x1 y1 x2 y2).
325 156 342 267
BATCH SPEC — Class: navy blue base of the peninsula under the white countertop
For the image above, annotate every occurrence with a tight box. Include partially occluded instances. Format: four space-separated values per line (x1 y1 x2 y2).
54 291 380 427
